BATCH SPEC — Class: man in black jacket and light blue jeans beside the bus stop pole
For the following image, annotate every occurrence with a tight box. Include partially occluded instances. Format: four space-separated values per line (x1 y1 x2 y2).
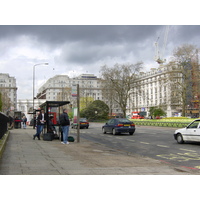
59 109 70 144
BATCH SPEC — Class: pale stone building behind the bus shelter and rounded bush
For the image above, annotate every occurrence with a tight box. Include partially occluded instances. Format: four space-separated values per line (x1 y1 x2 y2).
37 74 120 113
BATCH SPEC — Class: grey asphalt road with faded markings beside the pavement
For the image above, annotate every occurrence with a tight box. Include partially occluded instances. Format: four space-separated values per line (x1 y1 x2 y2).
71 123 200 169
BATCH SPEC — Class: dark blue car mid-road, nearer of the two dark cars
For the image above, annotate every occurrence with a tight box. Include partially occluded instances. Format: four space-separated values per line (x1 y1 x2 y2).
102 118 135 135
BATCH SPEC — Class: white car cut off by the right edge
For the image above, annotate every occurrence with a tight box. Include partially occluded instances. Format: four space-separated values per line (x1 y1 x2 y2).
174 119 200 144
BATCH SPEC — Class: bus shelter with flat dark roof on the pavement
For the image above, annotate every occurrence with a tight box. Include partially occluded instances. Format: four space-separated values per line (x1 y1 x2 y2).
40 101 70 141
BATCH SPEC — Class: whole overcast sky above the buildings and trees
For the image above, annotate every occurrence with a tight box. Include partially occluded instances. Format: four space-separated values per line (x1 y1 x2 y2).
0 25 200 99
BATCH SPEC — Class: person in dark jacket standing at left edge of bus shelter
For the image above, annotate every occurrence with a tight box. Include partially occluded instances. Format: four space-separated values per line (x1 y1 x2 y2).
33 109 47 140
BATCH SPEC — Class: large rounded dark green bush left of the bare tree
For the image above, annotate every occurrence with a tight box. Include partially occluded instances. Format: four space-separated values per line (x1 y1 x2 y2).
80 100 109 120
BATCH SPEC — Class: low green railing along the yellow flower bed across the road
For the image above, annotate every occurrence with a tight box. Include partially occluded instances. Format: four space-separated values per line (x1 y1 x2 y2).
134 120 189 128
